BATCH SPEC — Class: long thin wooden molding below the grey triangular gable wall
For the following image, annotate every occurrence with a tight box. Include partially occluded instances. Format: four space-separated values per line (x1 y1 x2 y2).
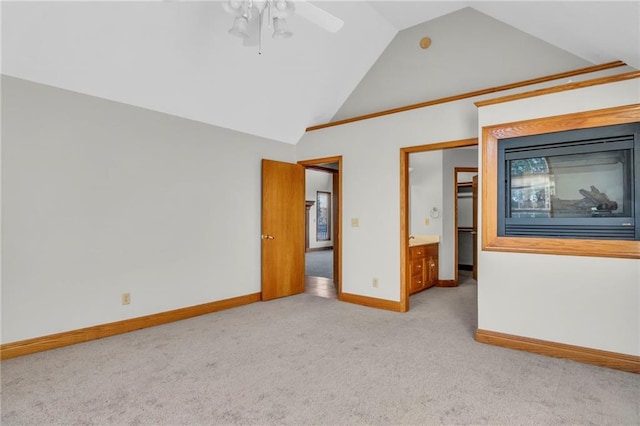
306 61 627 132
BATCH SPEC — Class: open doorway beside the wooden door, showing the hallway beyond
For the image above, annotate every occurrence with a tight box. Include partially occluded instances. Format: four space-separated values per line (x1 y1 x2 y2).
299 157 342 299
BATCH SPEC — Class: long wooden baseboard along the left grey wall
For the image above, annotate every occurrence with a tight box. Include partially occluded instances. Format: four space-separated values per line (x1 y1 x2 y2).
0 293 261 359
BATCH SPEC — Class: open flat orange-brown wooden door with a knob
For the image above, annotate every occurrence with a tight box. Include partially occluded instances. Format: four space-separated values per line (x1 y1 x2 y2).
262 160 305 300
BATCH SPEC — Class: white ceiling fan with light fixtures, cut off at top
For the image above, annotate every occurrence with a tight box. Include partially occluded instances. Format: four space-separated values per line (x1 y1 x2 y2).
222 0 344 54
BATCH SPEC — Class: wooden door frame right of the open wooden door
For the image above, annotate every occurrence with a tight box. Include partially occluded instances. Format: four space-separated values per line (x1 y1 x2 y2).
298 155 342 300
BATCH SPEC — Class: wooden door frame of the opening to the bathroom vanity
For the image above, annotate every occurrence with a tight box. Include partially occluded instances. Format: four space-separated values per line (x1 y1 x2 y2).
400 138 478 312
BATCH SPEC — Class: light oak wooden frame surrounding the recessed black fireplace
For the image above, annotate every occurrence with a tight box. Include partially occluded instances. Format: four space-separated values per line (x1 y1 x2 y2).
482 104 640 259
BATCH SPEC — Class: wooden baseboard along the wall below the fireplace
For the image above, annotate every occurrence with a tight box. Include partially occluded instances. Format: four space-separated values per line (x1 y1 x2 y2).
476 329 640 374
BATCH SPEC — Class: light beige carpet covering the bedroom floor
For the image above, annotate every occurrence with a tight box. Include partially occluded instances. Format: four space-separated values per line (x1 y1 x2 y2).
1 281 640 425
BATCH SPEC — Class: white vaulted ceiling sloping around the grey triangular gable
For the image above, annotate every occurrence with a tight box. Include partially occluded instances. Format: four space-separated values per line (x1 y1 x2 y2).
1 0 640 144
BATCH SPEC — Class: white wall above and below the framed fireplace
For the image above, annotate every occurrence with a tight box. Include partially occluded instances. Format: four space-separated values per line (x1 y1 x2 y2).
478 79 640 355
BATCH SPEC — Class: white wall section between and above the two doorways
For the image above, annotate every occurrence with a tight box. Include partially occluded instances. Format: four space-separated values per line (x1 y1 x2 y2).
297 101 477 301
